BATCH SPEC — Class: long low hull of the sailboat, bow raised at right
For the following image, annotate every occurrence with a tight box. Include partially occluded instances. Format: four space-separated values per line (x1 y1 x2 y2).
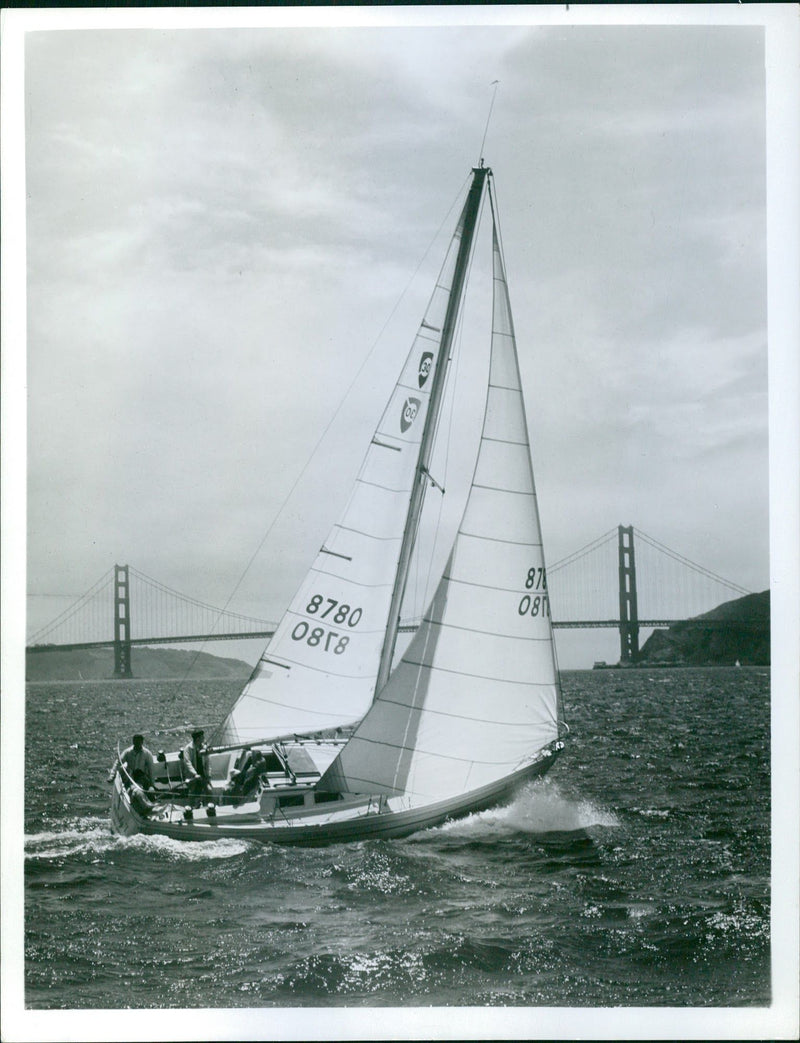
111 742 563 846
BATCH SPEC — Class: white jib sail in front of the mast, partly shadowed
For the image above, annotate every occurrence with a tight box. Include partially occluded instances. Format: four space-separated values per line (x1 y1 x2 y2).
320 211 559 803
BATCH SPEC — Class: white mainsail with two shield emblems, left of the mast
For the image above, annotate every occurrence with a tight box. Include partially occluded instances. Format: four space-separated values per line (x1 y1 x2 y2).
214 189 475 745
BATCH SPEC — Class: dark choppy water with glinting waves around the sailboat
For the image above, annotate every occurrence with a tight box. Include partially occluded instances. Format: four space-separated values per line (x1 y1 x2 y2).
25 668 770 1010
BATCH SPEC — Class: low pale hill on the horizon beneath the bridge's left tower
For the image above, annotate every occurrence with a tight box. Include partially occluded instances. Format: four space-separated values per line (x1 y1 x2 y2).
25 646 252 681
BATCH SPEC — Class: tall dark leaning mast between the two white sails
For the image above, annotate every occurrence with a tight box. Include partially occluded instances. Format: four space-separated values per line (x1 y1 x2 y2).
375 160 489 695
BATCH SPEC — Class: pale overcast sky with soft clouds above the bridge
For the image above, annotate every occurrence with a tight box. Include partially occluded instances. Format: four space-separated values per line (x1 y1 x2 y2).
18 14 769 665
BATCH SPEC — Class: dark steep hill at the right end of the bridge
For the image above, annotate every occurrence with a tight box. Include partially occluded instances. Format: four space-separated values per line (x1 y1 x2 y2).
637 590 770 666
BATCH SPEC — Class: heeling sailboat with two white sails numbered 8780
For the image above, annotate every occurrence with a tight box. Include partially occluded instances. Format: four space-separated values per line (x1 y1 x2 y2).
111 160 567 844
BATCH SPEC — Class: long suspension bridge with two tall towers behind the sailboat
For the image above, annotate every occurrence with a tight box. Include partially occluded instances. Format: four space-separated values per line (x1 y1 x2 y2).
27 526 751 678
